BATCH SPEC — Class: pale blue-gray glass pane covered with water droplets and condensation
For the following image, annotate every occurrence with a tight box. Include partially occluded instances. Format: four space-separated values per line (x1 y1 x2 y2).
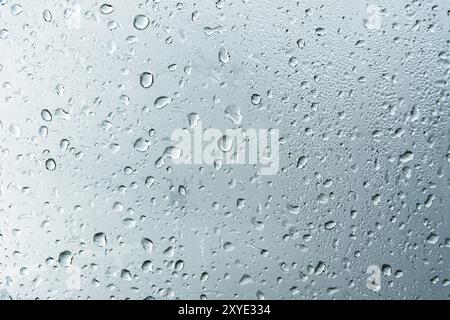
0 0 450 299
